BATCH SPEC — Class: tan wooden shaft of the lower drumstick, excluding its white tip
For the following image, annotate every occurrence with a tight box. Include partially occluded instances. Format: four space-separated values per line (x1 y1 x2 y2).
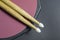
0 1 40 32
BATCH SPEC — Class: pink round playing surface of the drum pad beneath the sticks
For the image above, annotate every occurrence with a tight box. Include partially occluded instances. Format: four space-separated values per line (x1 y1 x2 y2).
0 0 37 38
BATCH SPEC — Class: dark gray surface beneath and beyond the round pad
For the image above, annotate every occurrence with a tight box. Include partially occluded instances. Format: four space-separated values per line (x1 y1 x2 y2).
15 0 60 40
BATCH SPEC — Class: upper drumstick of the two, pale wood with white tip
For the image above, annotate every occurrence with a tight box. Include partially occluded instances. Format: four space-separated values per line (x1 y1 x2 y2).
2 0 44 28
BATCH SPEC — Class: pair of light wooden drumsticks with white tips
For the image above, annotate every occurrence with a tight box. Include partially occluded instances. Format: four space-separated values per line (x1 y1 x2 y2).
0 0 44 33
